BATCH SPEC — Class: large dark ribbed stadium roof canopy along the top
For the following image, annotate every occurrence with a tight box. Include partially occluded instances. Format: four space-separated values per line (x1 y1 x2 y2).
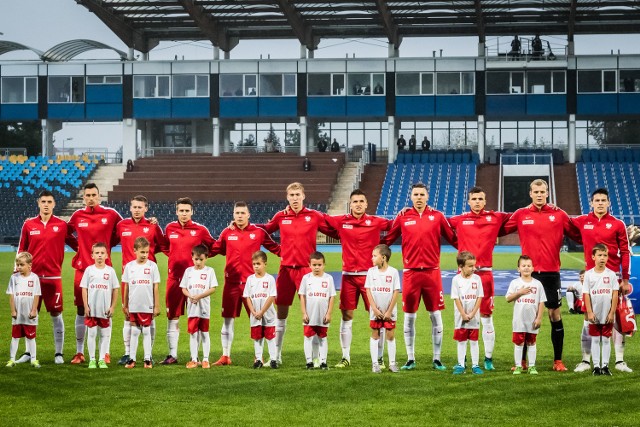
76 0 640 52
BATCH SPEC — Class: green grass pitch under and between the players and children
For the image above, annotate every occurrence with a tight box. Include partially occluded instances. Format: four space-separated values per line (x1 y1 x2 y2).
0 253 640 426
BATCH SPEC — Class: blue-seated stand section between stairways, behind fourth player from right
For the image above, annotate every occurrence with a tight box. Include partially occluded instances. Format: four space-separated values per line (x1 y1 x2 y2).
376 150 478 216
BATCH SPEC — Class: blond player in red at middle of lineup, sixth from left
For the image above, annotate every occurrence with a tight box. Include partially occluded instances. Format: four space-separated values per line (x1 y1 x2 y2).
264 182 336 363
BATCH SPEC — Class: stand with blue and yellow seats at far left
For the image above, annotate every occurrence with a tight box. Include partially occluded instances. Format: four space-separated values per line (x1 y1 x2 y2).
0 155 102 243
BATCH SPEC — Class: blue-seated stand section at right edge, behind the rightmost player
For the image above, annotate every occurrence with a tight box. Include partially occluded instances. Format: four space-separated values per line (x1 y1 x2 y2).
576 148 640 224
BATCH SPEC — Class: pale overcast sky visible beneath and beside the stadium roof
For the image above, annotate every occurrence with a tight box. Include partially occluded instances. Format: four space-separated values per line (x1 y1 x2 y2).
0 0 640 153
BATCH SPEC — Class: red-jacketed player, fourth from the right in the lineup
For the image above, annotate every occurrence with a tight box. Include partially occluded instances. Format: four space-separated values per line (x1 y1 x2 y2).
383 183 456 371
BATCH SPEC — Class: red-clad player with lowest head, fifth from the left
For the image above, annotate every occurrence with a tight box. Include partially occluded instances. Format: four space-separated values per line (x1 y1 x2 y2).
211 202 280 366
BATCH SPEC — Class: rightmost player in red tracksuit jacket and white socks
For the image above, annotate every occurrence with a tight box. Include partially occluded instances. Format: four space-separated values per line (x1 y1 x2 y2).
571 188 633 372
